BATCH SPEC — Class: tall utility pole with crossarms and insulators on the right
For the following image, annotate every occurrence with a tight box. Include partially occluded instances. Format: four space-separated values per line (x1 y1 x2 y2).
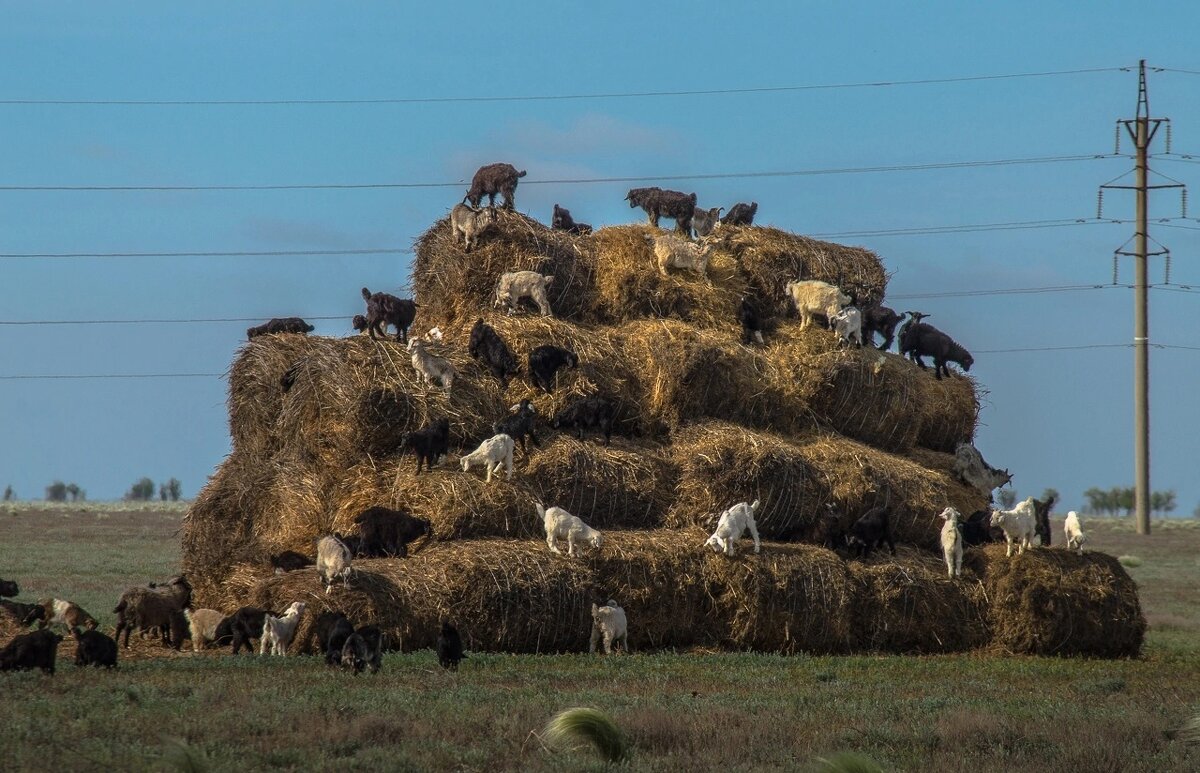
1100 59 1182 534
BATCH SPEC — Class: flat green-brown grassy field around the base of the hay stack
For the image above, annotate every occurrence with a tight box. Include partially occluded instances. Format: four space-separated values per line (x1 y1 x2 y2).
0 509 1200 772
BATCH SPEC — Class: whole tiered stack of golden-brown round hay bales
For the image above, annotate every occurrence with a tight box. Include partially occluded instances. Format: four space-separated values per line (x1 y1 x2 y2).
184 210 1145 655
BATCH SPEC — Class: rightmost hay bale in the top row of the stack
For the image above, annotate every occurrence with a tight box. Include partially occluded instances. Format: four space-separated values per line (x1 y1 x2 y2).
714 226 888 314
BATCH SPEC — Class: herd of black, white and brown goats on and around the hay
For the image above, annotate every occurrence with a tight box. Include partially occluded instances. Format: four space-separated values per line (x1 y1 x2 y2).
0 163 1085 673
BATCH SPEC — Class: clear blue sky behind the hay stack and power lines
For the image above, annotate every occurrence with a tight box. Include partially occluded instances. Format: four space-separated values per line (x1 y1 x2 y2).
0 2 1200 513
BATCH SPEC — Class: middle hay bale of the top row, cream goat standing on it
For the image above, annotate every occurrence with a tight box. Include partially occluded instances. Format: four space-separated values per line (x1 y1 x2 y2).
589 223 746 328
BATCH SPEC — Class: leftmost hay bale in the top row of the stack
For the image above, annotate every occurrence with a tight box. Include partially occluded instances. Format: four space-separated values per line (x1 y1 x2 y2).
413 209 595 324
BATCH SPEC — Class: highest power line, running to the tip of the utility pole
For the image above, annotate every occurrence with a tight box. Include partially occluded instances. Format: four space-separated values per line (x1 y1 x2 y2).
0 67 1128 107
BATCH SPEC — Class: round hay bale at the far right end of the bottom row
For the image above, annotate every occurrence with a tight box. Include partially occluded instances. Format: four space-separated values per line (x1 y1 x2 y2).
964 545 1146 658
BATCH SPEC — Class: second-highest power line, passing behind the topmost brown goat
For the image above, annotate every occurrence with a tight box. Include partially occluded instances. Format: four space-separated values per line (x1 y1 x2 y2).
0 154 1123 192
